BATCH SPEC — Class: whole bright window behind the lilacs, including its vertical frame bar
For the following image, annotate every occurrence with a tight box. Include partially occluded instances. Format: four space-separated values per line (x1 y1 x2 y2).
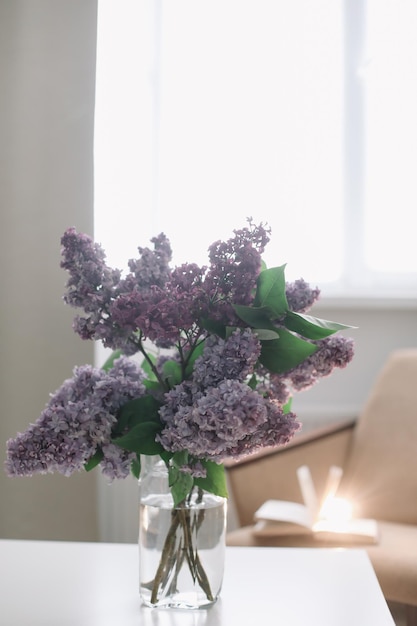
95 0 417 296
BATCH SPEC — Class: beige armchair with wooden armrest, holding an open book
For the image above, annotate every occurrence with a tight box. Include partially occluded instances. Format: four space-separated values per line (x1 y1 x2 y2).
227 349 417 626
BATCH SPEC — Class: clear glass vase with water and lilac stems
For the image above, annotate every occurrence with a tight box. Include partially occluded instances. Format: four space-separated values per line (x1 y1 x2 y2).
139 456 227 609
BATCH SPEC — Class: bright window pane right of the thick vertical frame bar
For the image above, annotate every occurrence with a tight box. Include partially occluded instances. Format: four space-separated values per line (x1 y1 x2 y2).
363 0 417 274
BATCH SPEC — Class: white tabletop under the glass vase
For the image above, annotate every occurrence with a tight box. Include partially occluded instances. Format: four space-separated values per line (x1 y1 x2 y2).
0 540 394 626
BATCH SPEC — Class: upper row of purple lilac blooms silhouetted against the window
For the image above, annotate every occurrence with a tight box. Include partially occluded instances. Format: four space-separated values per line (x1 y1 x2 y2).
61 221 269 355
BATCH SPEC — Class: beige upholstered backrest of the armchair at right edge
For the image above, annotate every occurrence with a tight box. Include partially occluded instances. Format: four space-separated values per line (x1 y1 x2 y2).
340 349 417 524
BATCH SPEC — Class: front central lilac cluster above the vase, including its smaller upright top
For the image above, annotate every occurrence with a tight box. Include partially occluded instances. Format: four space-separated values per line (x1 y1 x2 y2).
158 329 300 473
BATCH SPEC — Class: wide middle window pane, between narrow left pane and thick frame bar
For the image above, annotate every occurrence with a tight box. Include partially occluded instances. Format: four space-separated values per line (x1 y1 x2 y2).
154 0 343 280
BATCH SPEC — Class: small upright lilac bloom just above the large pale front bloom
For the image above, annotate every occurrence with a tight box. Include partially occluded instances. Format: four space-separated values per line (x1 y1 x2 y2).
193 328 261 388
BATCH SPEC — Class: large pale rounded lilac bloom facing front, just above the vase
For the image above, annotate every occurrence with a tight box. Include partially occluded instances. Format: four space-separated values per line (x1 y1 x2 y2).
157 380 267 462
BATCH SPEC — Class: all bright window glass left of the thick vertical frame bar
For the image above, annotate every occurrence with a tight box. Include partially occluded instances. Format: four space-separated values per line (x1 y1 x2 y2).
95 0 343 281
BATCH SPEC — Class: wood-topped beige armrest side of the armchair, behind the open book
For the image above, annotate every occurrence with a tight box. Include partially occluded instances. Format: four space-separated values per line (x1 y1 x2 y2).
225 420 356 526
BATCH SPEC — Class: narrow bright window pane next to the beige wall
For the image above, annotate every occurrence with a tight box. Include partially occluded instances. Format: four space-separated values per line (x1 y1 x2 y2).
94 0 154 269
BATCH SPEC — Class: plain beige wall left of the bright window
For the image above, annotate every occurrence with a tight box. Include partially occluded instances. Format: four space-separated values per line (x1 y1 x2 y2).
0 0 97 540
